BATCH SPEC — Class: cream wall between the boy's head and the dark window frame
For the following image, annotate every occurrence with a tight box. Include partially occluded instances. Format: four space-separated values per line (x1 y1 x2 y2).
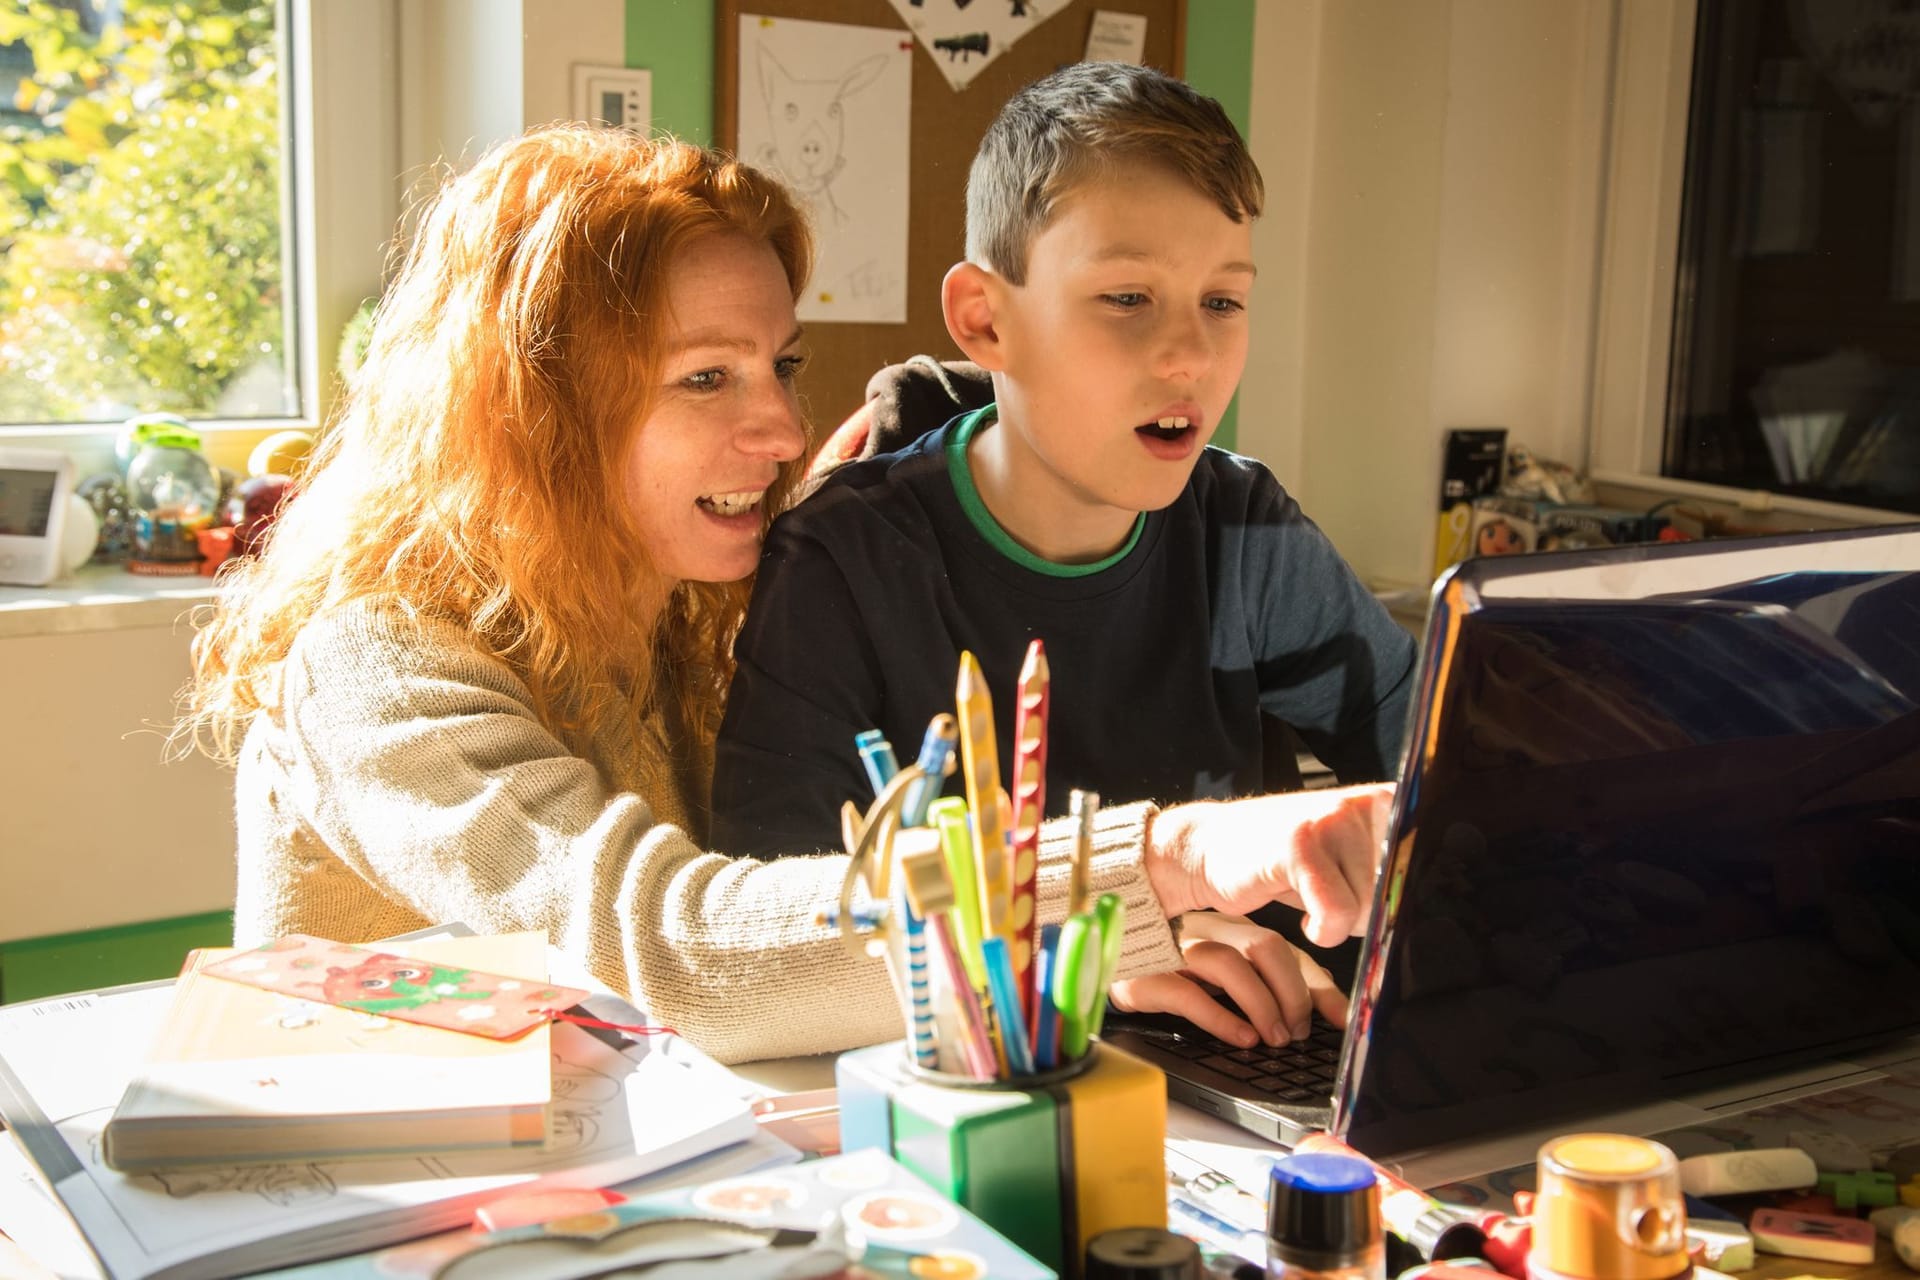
1240 0 1613 585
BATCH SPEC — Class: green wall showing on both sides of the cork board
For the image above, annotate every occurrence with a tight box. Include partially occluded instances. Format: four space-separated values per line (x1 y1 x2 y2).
626 0 1254 449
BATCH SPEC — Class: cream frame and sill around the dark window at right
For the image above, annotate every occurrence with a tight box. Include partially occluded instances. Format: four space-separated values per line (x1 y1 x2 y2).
1588 0 1914 524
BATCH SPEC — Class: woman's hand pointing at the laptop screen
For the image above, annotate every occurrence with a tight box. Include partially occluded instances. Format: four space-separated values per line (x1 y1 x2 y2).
1144 783 1394 946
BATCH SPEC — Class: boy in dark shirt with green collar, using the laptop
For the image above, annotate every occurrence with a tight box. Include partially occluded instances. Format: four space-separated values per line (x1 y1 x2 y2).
712 63 1413 1044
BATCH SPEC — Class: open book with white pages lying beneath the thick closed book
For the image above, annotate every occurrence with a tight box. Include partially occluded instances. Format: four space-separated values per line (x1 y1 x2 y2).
0 955 755 1280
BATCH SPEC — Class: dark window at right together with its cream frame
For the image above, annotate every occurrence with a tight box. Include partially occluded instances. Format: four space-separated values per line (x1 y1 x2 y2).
1592 0 1920 524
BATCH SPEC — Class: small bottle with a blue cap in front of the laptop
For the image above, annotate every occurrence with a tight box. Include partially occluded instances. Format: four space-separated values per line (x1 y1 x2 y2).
1267 1153 1386 1280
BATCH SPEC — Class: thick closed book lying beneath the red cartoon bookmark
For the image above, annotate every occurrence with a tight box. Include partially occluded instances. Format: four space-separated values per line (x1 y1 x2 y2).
100 933 553 1173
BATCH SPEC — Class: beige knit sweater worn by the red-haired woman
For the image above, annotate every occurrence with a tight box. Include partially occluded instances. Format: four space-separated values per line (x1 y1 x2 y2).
234 604 1181 1061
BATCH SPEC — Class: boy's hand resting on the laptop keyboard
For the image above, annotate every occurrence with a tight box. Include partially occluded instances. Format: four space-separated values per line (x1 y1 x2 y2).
1112 912 1346 1048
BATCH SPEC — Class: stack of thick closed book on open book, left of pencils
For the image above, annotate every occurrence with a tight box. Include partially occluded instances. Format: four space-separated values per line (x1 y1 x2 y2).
0 935 768 1280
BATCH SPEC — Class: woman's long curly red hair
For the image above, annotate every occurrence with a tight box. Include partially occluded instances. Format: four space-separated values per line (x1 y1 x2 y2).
177 125 812 782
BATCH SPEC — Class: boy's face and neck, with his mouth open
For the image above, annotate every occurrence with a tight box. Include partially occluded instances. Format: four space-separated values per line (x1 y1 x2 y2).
973 165 1254 558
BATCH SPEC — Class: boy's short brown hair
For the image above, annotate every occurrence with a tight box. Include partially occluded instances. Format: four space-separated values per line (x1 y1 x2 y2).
966 61 1265 284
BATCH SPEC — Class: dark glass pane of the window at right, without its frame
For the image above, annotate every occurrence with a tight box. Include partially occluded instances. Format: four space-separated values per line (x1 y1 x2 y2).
1661 0 1920 512
